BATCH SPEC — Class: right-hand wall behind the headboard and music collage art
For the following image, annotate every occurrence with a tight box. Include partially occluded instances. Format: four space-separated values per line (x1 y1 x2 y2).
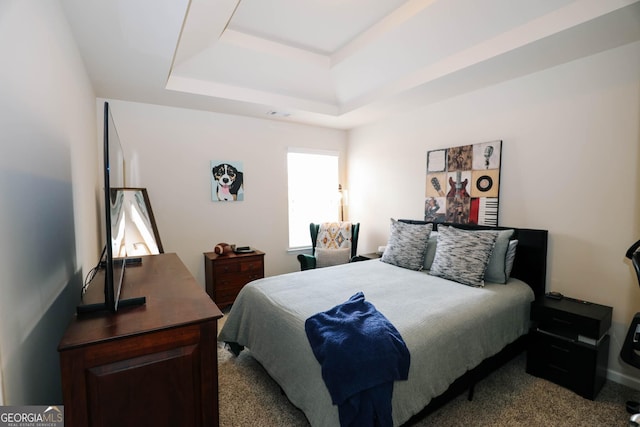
348 43 640 386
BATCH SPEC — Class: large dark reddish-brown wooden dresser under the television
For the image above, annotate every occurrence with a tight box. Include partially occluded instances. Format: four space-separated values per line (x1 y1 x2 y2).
58 254 222 427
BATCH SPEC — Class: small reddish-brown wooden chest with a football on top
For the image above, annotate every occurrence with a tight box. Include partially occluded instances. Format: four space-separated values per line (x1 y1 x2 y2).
204 250 264 308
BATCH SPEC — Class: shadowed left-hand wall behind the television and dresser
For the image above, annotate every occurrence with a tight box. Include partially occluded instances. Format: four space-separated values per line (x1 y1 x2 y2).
0 0 99 405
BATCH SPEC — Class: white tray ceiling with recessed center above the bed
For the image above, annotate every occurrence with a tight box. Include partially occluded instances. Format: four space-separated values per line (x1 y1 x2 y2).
61 0 640 129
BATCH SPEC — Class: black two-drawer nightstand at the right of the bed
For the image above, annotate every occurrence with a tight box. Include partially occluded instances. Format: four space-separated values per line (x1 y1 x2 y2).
527 297 613 400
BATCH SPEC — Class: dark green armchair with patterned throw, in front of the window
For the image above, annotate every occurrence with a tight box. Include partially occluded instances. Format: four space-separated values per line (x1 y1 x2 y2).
298 222 360 270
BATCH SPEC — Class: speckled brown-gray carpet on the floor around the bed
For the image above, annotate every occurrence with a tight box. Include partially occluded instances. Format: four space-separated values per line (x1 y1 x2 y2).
218 342 640 427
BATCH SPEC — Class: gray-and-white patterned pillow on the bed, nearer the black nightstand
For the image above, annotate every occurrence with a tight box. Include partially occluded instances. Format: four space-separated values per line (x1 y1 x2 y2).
429 226 498 286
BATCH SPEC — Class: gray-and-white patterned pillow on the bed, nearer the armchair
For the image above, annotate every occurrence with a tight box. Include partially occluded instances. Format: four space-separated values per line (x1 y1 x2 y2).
380 218 433 270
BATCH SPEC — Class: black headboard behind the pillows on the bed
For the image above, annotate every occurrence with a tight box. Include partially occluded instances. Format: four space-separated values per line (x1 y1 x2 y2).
399 219 549 298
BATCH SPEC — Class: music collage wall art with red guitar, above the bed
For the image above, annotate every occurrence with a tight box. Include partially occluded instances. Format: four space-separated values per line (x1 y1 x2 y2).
424 140 502 226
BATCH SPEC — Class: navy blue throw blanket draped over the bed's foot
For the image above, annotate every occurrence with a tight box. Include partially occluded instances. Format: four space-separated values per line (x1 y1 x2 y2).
305 292 410 427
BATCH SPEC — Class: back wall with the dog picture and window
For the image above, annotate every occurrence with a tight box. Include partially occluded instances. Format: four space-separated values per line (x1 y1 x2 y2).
99 100 346 286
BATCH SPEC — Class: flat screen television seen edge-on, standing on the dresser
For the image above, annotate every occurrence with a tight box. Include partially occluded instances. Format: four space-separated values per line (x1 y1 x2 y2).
77 102 146 314
